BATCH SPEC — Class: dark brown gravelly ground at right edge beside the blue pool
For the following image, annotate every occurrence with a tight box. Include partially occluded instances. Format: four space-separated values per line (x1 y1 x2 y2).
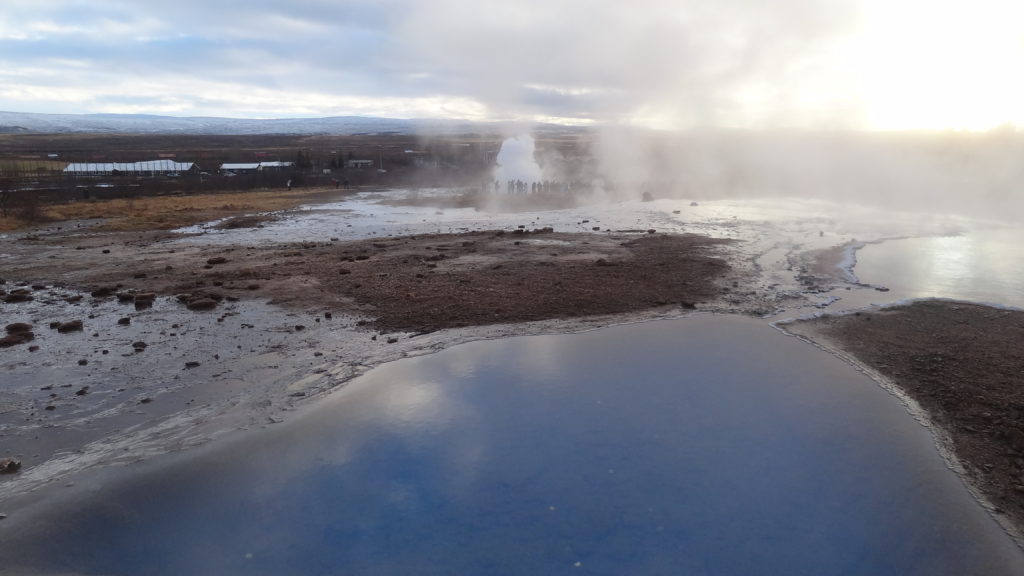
780 299 1024 541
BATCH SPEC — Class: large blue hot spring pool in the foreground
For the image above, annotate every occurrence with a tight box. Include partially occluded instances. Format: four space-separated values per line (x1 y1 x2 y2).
0 316 1024 576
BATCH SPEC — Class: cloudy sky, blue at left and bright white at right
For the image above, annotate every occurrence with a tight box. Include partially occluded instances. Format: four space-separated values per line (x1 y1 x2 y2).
0 0 1024 130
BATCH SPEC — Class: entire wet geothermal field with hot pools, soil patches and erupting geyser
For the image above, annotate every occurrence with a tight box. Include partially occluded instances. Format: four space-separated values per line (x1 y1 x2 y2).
0 126 1024 574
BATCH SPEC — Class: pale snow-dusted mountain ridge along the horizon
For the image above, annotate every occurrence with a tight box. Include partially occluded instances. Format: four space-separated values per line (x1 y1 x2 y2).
0 112 580 135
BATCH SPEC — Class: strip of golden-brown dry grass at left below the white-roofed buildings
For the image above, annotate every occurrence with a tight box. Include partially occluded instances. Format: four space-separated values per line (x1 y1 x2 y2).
0 189 337 231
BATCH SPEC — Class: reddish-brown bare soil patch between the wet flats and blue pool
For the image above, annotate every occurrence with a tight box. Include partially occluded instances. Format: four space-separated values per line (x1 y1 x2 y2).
7 231 731 332
